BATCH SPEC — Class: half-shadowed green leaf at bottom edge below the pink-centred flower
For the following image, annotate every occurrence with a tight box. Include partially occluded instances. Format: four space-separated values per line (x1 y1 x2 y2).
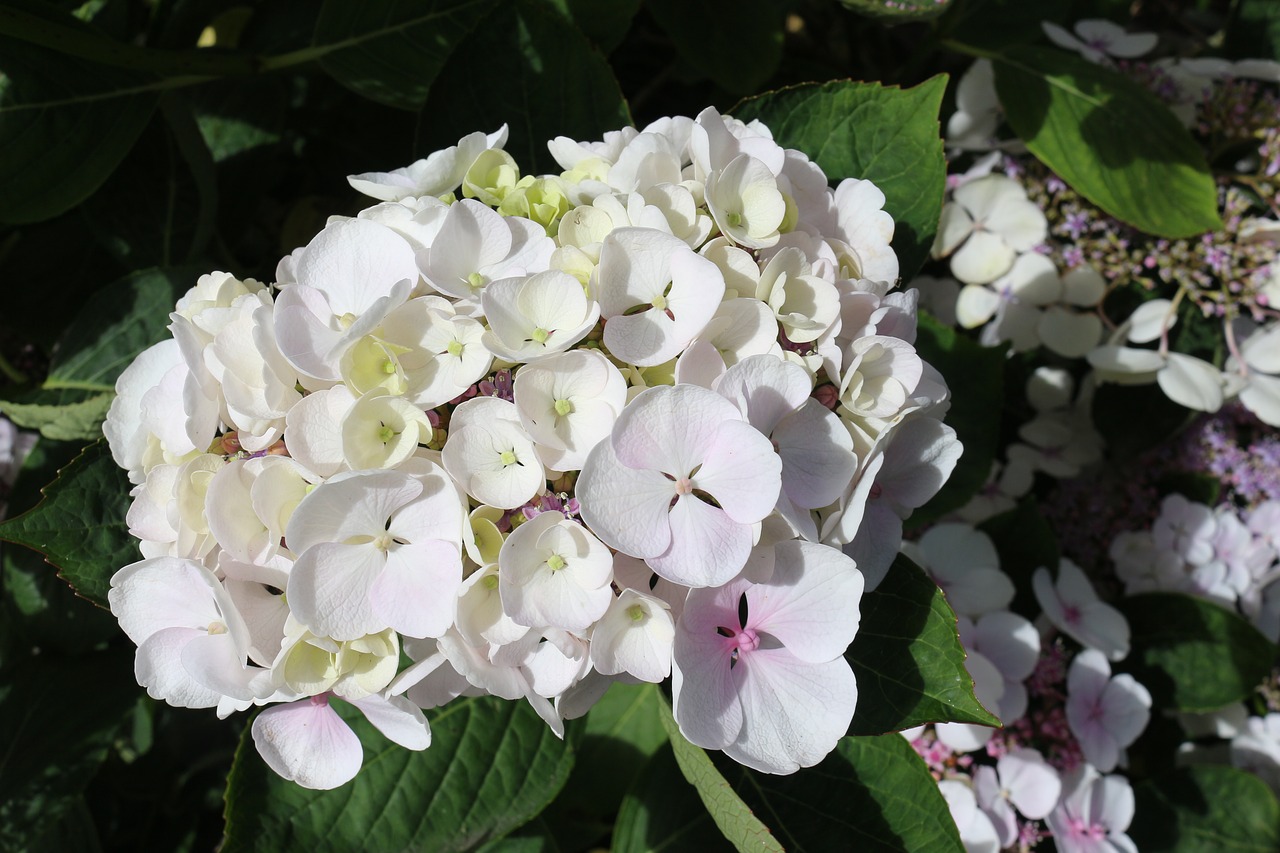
717 732 964 853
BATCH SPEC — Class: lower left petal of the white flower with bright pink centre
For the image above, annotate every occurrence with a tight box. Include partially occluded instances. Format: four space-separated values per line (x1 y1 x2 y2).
671 612 742 749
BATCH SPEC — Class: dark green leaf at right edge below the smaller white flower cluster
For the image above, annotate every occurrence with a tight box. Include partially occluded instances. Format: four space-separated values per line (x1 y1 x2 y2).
1116 593 1276 712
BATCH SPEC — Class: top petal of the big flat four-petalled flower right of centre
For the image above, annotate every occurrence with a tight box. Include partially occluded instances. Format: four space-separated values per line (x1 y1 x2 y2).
612 386 742 476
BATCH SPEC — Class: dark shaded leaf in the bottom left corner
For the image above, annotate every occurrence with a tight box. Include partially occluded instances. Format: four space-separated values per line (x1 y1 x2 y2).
0 648 138 850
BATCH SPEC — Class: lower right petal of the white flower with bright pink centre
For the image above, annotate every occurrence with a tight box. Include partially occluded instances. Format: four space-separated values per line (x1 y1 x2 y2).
724 648 858 774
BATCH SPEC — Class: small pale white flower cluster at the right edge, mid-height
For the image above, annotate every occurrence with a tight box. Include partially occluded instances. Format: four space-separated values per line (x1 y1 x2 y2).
1111 494 1280 642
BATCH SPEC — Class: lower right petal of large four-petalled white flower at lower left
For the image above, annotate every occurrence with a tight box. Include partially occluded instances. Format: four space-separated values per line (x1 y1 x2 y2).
369 539 462 638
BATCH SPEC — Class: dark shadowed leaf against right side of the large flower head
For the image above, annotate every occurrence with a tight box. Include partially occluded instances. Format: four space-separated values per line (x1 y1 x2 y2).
910 313 1005 526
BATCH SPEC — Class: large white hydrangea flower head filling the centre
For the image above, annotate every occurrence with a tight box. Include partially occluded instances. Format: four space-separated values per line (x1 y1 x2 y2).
105 109 960 788
